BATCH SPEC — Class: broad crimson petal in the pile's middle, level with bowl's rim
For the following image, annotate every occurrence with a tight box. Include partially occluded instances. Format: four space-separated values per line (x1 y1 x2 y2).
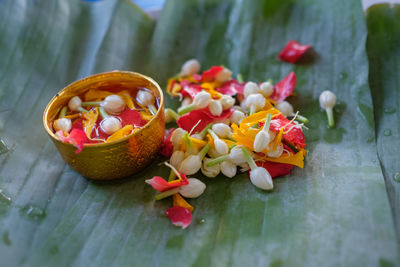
176 108 233 133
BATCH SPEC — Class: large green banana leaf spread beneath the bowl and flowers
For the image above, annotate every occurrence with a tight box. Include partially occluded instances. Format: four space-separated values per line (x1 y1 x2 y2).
0 0 398 266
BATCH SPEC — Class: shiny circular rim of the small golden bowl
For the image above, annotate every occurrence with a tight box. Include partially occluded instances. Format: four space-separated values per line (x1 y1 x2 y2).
43 70 164 148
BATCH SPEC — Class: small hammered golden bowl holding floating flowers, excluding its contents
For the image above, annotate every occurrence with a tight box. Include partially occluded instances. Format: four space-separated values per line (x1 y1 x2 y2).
43 71 165 180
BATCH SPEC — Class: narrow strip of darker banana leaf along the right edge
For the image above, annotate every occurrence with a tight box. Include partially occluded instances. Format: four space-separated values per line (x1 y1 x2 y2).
367 4 400 249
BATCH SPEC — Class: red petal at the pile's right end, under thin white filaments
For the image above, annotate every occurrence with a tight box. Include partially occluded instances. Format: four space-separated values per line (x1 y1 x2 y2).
269 115 306 148
